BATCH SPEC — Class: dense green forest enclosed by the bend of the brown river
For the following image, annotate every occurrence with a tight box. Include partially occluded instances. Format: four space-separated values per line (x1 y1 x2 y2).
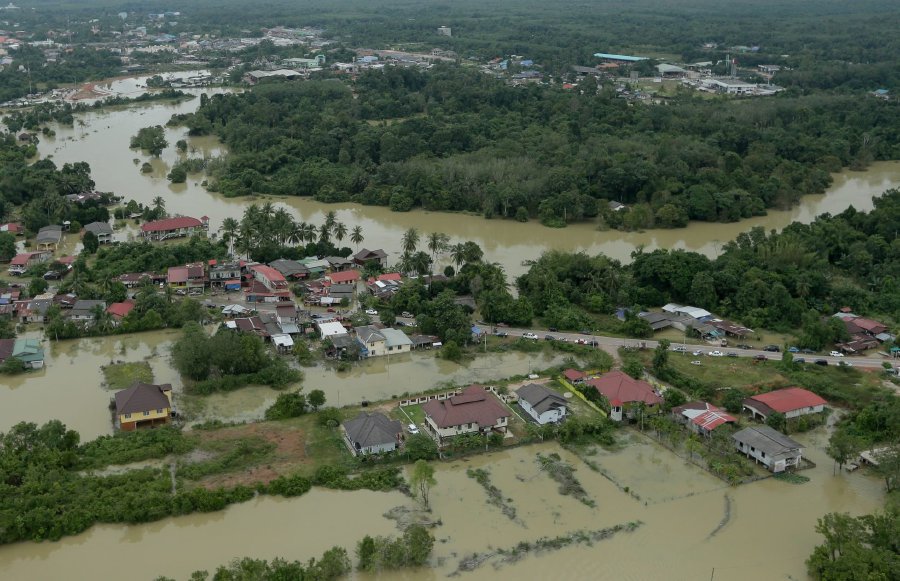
173 66 900 228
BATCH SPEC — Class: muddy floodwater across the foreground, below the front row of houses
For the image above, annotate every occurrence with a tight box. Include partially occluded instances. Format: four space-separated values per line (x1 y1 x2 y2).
0 435 882 581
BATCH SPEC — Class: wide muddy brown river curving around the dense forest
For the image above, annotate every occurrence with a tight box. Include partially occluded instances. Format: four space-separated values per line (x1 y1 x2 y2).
39 90 900 276
